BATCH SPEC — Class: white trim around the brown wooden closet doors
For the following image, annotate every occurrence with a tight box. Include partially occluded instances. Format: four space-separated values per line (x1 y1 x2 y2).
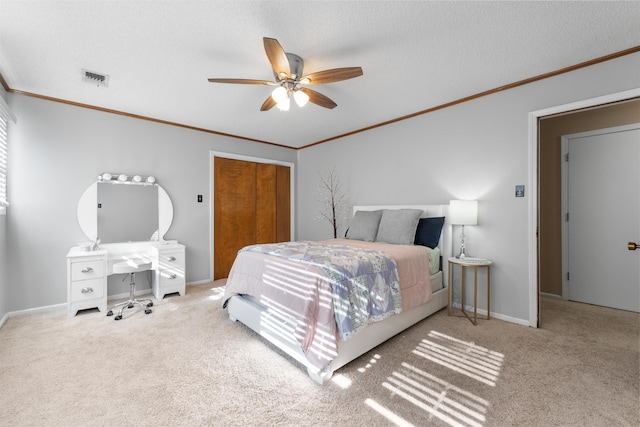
209 151 296 281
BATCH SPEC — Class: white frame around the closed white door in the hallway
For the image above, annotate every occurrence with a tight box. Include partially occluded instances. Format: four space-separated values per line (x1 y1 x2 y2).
560 123 640 300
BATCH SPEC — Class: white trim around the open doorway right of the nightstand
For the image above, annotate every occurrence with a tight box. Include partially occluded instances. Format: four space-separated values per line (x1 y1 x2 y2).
527 88 640 328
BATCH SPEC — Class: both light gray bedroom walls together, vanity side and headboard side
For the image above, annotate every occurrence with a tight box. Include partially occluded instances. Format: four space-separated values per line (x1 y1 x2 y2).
5 50 640 323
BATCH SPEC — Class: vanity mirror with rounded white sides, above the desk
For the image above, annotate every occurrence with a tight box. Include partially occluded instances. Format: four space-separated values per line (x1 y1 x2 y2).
78 181 173 243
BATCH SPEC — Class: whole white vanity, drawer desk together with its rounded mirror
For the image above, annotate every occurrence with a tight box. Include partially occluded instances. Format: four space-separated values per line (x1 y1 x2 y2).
67 174 186 316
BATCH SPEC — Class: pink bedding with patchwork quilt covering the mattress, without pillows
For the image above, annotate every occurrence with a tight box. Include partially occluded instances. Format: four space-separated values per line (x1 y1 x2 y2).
223 237 439 370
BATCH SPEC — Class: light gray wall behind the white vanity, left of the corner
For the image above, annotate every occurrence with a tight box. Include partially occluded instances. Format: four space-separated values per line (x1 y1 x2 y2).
5 94 296 311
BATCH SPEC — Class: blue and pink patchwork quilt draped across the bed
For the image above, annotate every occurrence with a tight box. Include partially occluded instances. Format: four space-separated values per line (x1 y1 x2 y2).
242 241 402 340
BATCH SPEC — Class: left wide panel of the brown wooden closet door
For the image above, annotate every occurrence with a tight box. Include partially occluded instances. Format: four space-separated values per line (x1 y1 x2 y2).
213 157 256 280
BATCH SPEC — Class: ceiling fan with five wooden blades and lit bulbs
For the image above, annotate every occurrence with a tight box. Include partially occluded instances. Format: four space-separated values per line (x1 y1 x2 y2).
209 37 362 111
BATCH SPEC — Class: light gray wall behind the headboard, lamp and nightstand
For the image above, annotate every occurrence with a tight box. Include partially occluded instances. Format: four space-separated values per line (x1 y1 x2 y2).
298 53 640 324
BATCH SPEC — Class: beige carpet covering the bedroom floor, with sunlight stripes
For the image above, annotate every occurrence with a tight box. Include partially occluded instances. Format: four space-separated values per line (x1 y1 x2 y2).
0 281 640 426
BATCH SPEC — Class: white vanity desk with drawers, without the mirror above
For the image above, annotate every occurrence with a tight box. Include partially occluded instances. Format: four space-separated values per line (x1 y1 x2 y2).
67 240 186 316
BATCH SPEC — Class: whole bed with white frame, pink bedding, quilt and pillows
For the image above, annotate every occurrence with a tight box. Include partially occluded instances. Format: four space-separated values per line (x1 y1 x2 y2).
223 205 451 384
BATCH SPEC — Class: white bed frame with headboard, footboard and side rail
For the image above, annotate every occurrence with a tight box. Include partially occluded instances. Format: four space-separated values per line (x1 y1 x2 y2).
227 205 452 384
